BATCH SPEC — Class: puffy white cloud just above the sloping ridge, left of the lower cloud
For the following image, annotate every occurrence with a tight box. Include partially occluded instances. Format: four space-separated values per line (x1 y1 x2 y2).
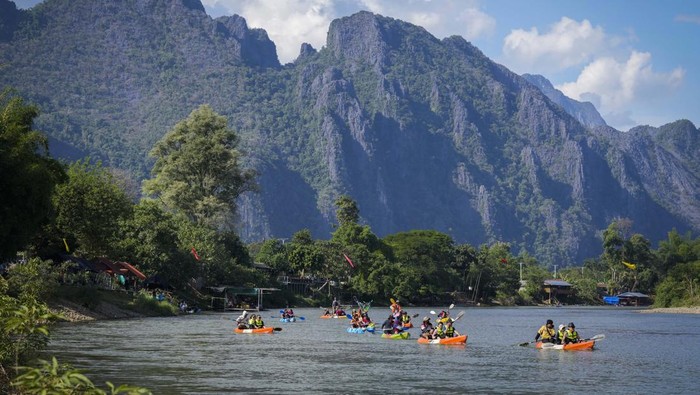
503 17 610 72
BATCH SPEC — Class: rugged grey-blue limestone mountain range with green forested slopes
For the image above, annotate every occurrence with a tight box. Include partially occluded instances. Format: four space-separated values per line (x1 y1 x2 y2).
0 0 700 265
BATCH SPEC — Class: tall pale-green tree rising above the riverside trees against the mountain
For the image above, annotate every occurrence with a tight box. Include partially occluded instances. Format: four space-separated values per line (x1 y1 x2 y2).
144 105 255 229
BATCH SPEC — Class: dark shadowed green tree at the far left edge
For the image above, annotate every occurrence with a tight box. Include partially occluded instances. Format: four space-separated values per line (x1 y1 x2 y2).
0 90 65 259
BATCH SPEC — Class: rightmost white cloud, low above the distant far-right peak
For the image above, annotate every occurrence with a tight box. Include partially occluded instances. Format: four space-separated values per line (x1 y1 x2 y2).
557 51 685 128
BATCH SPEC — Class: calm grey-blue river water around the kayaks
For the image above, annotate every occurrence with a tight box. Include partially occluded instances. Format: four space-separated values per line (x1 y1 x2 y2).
49 307 700 395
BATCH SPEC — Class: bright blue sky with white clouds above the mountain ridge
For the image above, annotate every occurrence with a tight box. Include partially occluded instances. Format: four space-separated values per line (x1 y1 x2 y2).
15 0 700 131
